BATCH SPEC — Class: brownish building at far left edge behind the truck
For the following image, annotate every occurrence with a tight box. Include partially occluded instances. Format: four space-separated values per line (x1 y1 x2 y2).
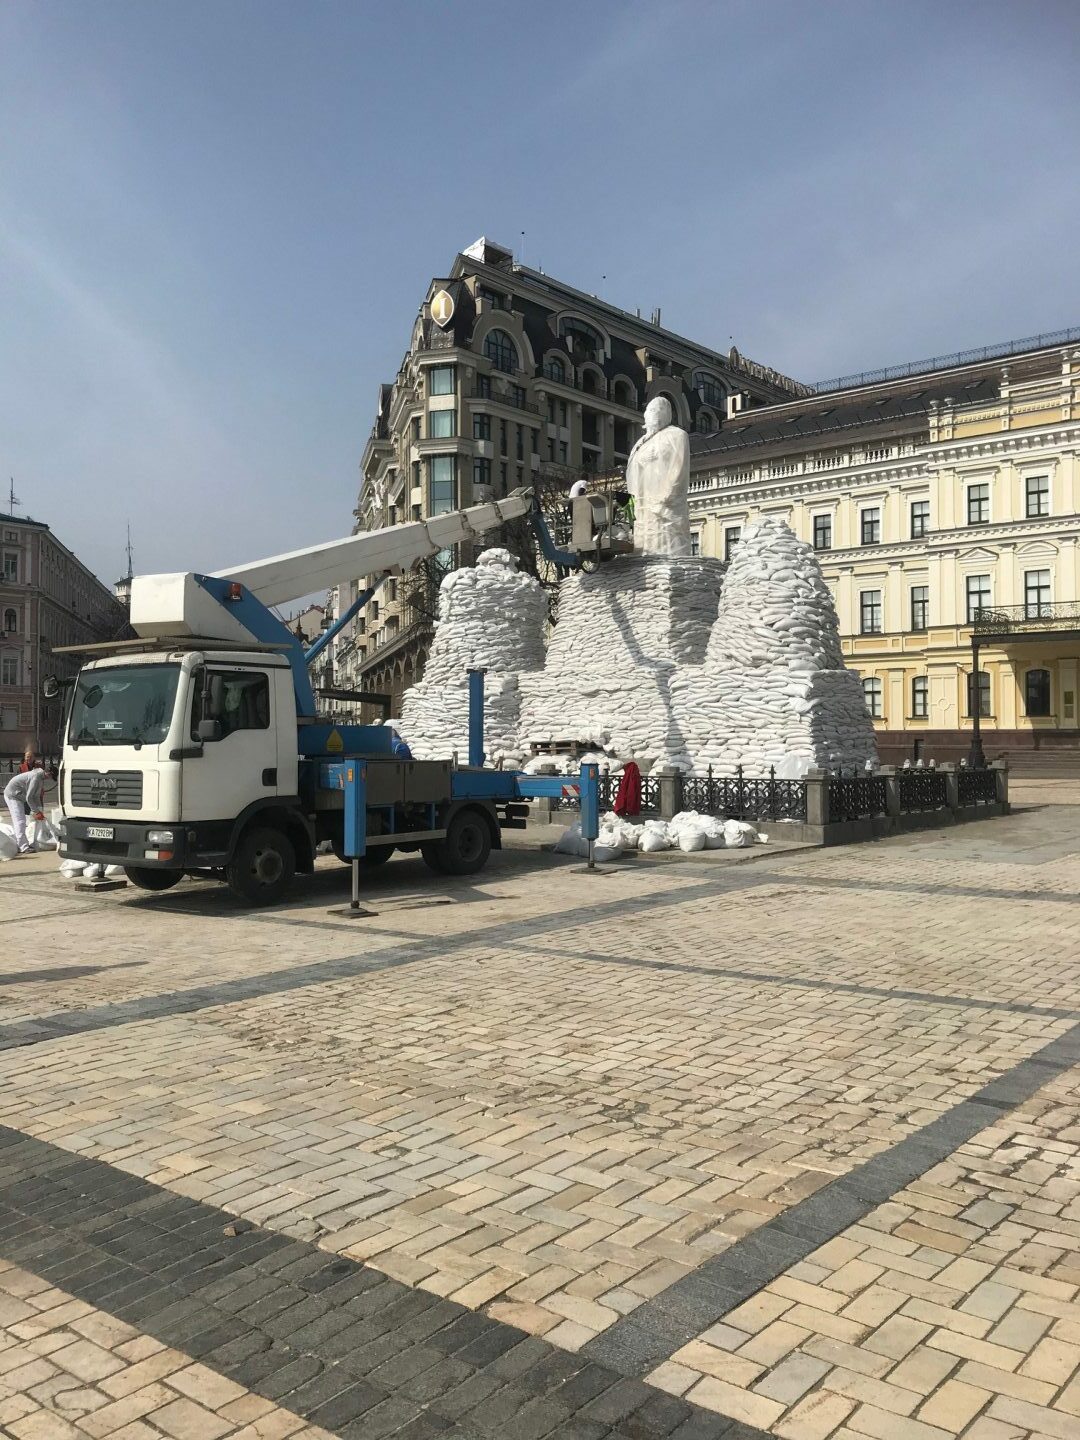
0 514 127 760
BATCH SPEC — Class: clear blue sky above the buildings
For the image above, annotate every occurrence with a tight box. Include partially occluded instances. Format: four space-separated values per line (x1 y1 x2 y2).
0 0 1080 580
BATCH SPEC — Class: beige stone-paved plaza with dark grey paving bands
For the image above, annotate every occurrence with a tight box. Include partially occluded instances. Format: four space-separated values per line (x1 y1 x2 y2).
0 793 1080 1440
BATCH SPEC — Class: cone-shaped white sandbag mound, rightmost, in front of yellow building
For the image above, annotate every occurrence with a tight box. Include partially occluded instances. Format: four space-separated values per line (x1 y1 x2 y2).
671 518 877 778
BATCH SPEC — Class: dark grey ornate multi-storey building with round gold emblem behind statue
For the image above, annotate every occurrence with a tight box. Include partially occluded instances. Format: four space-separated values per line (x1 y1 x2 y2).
342 239 805 713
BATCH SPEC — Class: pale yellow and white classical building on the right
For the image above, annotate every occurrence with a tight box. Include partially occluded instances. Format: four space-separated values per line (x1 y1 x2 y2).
690 331 1080 760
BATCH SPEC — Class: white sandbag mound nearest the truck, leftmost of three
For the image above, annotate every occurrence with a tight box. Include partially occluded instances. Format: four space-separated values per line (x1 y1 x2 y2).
397 549 547 763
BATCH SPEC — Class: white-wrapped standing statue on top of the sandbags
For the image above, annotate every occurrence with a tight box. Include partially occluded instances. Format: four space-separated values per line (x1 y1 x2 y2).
626 395 690 556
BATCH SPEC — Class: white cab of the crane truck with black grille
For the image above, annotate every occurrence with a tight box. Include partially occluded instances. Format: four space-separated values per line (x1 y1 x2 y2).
60 647 314 890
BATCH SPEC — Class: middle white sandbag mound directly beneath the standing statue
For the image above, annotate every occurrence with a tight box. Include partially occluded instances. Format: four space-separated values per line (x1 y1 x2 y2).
520 554 723 768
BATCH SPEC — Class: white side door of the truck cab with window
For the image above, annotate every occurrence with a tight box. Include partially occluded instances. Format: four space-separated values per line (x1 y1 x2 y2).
181 664 278 821
